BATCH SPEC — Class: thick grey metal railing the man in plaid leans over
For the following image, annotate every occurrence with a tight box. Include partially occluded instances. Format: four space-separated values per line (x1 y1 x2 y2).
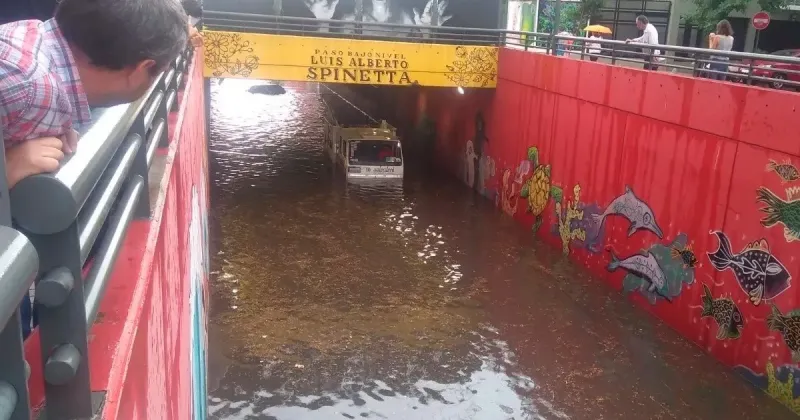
0 42 193 420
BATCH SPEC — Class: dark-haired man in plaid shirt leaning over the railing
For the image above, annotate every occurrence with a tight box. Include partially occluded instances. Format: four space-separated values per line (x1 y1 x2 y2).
0 0 188 338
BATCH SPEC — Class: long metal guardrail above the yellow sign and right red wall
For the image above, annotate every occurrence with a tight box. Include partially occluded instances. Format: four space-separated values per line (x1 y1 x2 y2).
203 10 800 88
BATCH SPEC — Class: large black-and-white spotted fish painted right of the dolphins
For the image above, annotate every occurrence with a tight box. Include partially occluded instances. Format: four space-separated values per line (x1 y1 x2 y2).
708 231 792 305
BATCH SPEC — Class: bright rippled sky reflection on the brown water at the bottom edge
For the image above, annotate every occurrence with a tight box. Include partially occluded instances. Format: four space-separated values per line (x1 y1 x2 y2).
211 327 534 419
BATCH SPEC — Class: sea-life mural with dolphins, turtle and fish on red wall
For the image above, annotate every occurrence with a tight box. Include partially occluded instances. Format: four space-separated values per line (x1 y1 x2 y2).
412 52 800 414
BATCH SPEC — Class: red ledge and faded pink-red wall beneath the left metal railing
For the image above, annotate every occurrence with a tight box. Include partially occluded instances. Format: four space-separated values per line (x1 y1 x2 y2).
25 52 208 420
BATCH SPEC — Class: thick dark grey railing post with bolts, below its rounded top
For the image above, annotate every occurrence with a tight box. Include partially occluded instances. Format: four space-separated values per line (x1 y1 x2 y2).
23 221 94 420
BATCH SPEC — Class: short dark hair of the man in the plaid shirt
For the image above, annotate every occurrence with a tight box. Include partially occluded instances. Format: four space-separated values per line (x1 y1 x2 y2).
55 0 189 72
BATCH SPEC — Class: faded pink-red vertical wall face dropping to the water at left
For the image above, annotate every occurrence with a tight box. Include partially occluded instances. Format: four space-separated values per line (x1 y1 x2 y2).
104 53 208 419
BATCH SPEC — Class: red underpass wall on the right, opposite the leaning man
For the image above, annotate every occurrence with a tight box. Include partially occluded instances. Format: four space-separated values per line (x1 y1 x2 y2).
406 49 800 409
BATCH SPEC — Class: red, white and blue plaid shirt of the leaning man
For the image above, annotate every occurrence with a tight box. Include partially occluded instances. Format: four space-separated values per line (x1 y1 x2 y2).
0 19 91 147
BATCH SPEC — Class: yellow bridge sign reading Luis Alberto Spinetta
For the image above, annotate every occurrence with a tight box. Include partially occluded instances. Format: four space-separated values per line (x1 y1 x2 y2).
204 31 497 88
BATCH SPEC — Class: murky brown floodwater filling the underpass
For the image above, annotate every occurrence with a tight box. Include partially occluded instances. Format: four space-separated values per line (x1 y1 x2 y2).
209 80 793 420
